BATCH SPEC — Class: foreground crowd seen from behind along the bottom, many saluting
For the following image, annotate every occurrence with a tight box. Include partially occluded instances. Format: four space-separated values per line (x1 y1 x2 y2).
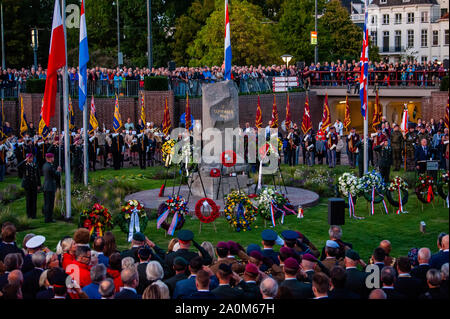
0 222 449 302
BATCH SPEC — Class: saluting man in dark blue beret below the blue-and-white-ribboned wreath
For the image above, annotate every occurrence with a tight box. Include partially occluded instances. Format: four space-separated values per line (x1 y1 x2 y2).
165 229 212 276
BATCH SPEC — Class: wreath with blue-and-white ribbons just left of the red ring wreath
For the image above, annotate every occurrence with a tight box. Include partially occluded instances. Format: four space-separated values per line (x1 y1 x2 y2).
156 196 189 236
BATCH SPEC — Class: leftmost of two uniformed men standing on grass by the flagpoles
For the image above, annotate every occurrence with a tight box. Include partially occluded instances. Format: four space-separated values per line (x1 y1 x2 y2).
22 153 41 219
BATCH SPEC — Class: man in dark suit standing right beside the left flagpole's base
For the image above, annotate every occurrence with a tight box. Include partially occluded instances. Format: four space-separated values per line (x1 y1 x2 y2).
42 153 61 223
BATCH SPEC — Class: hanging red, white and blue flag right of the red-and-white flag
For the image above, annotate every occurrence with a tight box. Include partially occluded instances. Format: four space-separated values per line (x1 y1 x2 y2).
78 0 89 111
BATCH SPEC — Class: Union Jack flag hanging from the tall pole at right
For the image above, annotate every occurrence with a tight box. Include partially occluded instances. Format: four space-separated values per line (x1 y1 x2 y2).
359 0 369 119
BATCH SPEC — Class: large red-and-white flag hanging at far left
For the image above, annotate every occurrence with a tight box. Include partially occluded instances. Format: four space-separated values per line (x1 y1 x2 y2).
42 0 66 126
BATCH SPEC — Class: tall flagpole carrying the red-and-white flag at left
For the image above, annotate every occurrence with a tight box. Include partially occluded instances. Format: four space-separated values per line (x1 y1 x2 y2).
58 0 72 219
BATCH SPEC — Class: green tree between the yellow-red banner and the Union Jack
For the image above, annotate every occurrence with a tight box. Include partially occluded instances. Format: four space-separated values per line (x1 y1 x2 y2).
318 0 363 61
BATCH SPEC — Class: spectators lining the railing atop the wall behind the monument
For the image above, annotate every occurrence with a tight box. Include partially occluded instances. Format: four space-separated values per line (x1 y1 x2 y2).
0 59 448 96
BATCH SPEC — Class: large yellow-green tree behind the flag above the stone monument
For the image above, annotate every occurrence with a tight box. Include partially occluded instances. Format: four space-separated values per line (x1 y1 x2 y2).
187 0 279 66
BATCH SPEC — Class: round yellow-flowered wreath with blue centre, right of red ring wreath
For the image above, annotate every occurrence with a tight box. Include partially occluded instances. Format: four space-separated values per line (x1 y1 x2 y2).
225 191 257 232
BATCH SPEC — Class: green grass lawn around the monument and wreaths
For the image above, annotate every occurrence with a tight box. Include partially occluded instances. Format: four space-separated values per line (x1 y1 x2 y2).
0 166 449 260
